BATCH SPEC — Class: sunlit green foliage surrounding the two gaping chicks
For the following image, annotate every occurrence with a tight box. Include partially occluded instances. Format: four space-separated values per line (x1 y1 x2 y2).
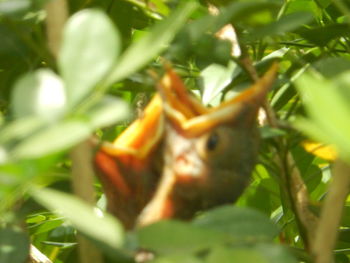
0 0 350 263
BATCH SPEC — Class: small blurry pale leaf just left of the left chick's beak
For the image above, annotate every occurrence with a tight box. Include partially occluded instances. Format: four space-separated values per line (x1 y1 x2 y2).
86 96 129 129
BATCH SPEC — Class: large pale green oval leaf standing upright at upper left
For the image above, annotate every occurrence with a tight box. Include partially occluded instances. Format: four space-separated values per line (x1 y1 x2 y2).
58 9 120 105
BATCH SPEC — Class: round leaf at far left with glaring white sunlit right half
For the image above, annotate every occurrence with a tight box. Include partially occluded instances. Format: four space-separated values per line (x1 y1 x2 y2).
11 69 66 121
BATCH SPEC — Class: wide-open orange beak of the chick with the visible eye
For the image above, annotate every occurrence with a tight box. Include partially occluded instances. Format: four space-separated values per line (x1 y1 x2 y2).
158 63 278 137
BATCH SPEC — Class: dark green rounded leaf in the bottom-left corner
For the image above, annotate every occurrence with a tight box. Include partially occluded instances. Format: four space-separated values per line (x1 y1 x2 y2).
0 228 29 263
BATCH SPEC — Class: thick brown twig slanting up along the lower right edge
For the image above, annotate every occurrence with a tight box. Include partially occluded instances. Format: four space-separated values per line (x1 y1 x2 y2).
312 160 350 263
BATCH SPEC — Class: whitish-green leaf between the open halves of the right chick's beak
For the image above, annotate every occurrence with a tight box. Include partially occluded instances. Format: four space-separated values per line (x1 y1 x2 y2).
200 61 240 105
